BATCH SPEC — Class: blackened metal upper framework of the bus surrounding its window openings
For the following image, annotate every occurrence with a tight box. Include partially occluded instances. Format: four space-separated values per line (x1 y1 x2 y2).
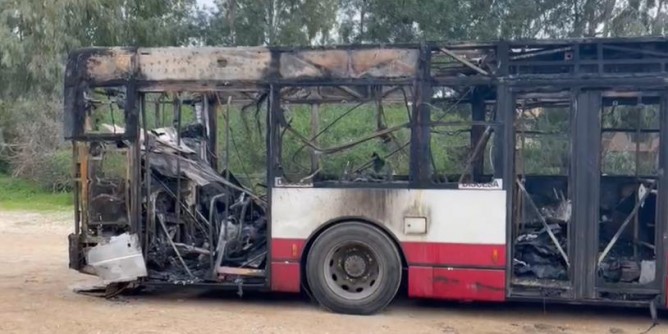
65 39 668 306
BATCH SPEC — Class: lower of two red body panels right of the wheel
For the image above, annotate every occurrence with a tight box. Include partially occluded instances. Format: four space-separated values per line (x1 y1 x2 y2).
408 267 506 302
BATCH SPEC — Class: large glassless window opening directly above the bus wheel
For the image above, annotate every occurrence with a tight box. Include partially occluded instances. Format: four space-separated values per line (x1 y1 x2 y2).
279 87 411 186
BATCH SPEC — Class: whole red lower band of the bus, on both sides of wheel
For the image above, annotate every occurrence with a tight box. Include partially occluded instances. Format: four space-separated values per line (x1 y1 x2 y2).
271 239 506 301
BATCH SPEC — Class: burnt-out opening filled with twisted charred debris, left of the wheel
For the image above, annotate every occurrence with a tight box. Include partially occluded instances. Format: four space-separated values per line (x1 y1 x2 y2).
134 92 267 283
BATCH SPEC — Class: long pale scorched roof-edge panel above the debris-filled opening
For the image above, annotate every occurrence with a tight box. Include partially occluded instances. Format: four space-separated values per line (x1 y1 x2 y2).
139 48 271 81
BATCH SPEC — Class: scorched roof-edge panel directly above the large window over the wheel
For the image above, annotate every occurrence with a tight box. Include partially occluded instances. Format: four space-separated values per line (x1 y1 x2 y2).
280 49 419 79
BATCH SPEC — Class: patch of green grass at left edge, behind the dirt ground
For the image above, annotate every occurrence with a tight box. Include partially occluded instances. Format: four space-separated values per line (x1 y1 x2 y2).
0 175 73 211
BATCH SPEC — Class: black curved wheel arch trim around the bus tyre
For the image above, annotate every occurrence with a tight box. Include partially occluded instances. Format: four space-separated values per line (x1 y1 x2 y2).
299 216 408 290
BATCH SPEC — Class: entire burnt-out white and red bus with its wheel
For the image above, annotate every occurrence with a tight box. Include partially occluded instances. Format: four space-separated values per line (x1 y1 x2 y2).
64 38 668 314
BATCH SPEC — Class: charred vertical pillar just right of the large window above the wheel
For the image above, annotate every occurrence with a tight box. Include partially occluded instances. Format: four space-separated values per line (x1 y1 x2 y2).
409 45 433 188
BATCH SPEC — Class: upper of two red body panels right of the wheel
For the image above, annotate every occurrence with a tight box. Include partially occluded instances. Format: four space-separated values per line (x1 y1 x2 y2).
402 242 506 269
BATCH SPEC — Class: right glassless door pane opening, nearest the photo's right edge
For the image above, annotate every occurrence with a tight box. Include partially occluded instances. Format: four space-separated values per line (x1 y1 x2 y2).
597 94 660 285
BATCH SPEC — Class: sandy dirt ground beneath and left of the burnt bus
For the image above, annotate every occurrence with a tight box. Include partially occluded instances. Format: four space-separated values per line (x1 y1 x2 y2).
0 212 668 334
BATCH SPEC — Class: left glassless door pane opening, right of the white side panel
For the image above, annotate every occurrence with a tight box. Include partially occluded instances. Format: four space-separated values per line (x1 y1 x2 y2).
512 96 572 287
